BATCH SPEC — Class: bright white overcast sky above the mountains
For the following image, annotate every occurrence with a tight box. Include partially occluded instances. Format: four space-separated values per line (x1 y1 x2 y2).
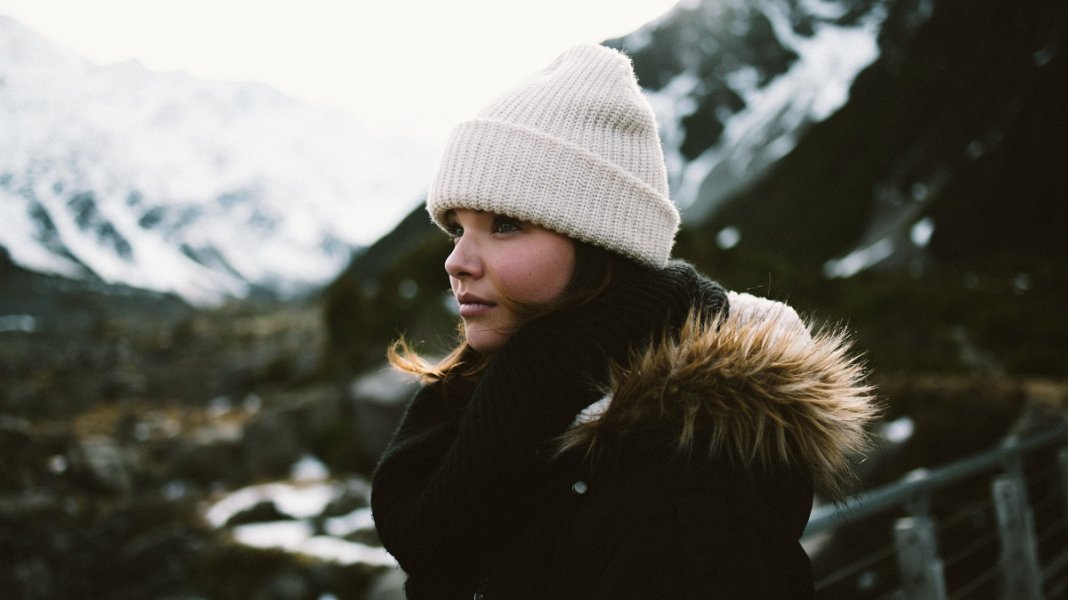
0 0 677 145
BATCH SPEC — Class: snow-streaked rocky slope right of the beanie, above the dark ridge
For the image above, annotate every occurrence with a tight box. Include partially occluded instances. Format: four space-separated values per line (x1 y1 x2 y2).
608 0 886 221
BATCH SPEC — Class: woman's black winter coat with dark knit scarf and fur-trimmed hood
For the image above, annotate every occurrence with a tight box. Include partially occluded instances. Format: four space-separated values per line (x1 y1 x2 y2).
372 264 871 600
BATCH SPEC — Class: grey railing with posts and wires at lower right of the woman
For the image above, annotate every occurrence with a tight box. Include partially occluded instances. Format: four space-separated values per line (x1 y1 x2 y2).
802 427 1068 600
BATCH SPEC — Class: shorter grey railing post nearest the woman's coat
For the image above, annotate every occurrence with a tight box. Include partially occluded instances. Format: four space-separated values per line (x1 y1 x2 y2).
894 516 946 600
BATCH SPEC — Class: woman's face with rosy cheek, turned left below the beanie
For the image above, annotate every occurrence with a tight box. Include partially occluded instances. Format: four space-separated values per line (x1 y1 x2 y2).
445 208 575 352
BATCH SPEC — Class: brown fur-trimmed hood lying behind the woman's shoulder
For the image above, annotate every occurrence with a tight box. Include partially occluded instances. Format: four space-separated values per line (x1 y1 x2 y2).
562 293 878 498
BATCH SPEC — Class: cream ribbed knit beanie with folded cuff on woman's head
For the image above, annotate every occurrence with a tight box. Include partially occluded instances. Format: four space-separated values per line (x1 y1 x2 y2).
426 44 679 267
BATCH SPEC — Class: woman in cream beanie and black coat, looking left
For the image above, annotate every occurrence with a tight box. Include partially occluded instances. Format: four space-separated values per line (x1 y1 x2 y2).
372 46 873 599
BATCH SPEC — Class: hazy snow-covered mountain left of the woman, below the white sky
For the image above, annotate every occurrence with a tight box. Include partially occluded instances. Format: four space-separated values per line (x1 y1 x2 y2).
0 16 433 303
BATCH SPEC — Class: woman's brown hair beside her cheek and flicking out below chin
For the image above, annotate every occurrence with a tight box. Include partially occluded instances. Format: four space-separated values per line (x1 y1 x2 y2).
386 240 639 384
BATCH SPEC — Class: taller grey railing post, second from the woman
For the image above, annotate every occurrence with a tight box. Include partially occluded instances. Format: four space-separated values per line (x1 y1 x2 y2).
992 475 1042 600
